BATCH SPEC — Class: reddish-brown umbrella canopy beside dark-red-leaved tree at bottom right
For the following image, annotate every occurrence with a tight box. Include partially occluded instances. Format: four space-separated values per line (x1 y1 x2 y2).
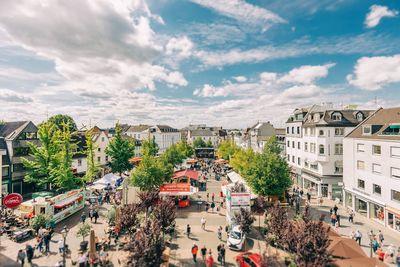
328 237 366 258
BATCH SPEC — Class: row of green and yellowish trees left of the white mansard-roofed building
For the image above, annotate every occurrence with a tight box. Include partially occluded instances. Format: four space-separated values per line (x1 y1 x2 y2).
217 137 292 199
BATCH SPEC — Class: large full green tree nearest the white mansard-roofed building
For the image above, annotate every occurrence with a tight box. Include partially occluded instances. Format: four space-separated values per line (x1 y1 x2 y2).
244 138 292 196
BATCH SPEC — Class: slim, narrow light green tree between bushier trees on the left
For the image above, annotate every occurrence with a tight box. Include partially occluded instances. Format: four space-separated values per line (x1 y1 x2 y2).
51 125 82 191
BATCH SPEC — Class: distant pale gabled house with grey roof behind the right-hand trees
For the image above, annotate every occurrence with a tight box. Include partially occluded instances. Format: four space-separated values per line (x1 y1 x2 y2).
243 122 276 153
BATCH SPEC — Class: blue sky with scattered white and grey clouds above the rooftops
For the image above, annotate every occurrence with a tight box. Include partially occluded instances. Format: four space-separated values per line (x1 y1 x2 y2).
0 0 400 128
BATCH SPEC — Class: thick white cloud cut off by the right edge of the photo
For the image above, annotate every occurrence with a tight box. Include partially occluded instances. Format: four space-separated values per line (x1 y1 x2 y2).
347 54 400 90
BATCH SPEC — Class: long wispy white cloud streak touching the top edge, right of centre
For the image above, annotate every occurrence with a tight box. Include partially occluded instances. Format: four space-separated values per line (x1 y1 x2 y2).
192 0 286 31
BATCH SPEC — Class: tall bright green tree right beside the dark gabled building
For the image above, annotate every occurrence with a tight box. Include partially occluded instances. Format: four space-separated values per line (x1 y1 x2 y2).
22 122 60 185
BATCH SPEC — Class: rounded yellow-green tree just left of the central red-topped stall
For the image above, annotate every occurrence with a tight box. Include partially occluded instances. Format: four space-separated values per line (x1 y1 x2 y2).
131 155 173 191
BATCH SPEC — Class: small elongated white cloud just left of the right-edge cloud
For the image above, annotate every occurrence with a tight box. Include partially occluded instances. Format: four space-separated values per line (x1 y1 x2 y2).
279 63 335 84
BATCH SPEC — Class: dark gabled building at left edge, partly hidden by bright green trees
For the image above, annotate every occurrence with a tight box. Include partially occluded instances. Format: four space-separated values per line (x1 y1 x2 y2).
0 121 39 195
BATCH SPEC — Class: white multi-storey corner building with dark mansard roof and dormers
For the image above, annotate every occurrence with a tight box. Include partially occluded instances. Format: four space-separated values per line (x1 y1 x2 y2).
286 104 370 199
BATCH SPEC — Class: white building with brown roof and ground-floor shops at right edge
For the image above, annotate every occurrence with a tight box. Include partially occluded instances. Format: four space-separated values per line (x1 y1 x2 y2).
343 108 400 231
